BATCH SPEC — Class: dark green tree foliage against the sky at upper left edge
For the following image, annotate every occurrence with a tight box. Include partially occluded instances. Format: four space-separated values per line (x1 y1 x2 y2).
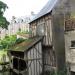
0 1 9 29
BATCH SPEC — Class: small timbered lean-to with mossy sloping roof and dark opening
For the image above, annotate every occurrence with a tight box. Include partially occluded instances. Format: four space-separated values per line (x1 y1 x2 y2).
8 37 43 75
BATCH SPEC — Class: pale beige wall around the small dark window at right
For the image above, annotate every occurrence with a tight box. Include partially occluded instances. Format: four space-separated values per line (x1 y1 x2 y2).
65 30 75 72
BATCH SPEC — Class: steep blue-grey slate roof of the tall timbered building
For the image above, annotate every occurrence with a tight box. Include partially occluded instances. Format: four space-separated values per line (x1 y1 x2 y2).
30 0 58 23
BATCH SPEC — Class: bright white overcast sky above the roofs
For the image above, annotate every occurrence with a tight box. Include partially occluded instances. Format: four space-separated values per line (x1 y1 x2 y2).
0 0 48 21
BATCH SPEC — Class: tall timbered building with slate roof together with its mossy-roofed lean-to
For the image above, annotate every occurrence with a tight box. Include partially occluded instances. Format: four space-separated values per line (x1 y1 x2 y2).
8 0 56 75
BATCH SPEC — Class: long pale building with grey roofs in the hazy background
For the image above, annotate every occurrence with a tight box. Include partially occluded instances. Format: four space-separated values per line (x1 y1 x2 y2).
0 16 30 39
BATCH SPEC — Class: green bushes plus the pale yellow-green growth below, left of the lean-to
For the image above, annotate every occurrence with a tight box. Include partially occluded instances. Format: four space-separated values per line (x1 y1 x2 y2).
0 35 25 65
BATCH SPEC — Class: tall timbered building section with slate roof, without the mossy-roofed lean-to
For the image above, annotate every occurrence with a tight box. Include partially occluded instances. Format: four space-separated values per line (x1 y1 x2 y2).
29 0 57 71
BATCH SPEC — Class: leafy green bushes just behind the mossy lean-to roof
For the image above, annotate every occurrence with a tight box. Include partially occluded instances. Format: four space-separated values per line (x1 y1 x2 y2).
0 35 24 50
